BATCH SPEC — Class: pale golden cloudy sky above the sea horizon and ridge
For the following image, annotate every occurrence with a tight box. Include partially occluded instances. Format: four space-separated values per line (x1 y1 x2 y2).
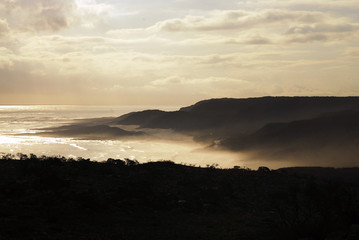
0 0 359 105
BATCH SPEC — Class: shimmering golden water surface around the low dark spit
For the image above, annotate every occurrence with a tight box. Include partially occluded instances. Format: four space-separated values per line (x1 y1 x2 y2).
0 105 245 167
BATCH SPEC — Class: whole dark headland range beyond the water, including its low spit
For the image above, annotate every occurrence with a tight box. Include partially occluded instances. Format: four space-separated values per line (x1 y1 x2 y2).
37 97 359 167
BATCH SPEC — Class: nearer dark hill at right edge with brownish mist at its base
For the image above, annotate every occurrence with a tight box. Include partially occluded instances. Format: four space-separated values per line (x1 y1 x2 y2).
221 111 359 166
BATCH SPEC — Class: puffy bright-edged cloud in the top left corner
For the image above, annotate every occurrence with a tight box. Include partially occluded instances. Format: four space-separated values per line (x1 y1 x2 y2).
0 0 113 33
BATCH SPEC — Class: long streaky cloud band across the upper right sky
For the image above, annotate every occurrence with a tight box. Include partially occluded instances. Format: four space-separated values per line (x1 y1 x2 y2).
147 9 359 45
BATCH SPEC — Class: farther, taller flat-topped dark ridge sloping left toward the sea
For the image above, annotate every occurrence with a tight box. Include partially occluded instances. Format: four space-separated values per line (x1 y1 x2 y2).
115 97 359 135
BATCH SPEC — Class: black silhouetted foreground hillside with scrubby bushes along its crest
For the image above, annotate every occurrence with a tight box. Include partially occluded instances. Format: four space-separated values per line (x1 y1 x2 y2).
0 155 359 240
